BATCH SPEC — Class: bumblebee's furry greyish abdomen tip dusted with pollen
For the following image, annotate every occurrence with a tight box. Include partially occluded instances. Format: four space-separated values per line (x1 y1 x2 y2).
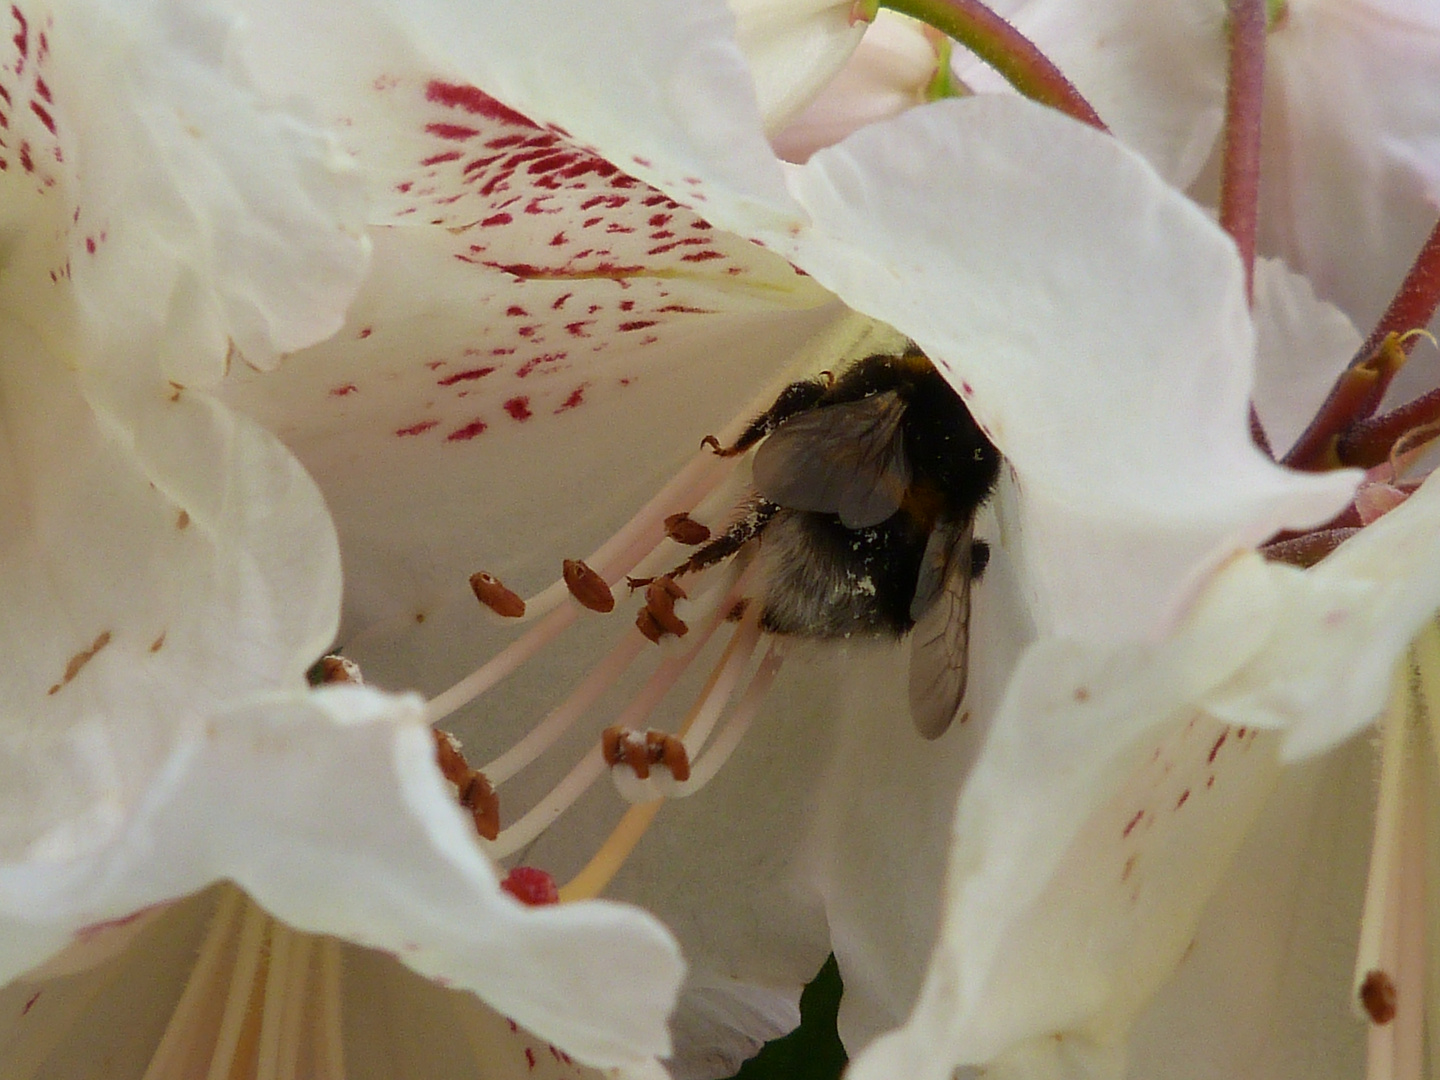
759 510 926 638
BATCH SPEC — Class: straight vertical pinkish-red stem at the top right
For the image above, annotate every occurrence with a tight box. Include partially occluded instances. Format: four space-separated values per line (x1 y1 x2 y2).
1220 0 1266 304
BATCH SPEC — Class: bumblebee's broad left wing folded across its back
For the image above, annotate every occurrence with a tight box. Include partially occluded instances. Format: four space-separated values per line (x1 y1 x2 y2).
755 390 910 528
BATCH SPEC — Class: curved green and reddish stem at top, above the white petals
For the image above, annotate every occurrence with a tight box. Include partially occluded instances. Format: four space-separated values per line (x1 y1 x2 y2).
855 0 1106 131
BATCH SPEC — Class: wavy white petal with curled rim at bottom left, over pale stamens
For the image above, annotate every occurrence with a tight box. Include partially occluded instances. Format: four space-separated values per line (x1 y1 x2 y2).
0 687 681 1066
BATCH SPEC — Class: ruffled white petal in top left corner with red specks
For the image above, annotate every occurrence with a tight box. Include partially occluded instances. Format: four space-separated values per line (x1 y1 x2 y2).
16 3 367 383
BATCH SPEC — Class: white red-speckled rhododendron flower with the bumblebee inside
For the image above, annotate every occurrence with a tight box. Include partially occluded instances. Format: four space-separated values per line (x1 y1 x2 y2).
200 4 1356 1074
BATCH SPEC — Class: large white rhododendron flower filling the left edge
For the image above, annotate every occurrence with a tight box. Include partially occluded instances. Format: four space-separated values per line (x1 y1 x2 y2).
0 3 681 1074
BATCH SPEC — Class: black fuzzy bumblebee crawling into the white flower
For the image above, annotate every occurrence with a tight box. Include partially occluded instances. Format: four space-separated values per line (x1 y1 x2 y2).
671 343 1001 739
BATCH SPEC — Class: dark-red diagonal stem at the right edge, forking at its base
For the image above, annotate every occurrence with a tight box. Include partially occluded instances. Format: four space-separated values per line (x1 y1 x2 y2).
1284 223 1440 471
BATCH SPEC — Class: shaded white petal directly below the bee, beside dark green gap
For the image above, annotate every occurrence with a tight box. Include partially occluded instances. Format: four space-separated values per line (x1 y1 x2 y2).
812 495 1034 1054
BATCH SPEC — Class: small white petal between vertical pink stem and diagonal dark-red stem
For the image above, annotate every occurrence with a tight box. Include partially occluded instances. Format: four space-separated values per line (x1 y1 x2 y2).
1254 259 1361 455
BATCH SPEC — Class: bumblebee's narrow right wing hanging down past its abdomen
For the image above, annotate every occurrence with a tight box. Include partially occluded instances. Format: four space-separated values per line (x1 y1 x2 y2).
910 521 975 739
